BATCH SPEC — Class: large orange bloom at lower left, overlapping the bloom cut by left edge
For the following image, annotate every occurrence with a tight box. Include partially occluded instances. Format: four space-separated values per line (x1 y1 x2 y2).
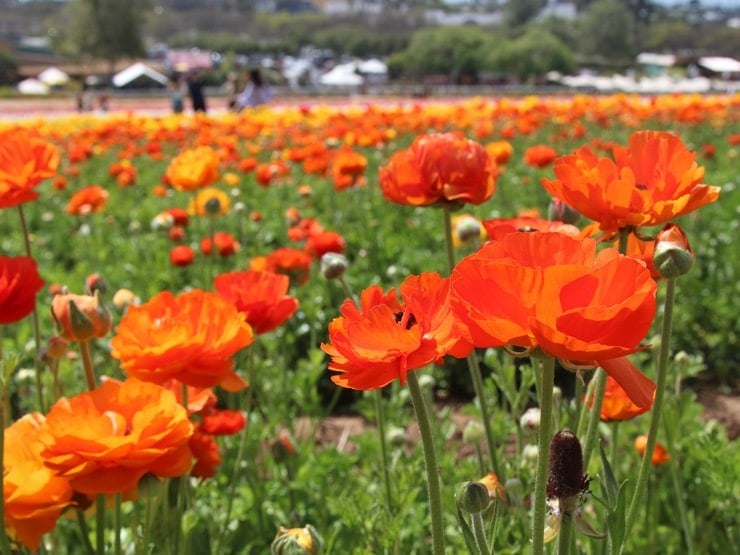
41 378 193 495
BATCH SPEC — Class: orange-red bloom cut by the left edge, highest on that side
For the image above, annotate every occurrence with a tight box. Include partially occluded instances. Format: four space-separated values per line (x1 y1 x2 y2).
0 128 60 208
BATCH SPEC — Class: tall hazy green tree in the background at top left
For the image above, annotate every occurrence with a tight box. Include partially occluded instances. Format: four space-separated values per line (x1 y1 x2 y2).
57 0 151 71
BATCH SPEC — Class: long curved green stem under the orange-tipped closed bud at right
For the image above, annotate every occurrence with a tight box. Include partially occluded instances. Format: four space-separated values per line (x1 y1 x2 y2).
622 278 676 547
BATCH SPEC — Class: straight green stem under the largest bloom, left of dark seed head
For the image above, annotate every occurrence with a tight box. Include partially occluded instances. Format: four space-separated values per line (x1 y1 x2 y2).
532 357 555 555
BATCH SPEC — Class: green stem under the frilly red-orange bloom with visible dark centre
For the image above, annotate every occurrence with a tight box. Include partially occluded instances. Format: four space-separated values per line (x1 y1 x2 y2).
408 371 445 555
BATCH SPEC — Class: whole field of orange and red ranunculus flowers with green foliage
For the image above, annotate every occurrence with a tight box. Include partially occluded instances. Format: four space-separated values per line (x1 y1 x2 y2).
0 95 740 555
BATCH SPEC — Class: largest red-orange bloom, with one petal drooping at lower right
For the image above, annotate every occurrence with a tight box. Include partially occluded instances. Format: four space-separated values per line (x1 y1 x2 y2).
450 232 657 406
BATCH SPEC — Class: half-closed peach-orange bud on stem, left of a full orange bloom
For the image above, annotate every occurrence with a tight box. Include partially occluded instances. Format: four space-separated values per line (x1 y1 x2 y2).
51 291 112 341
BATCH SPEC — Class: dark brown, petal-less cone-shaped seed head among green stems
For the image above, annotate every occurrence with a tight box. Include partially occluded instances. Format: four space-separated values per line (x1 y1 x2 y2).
547 430 588 507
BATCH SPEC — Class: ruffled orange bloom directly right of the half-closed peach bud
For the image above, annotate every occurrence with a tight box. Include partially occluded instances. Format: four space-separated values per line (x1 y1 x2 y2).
111 289 254 391
